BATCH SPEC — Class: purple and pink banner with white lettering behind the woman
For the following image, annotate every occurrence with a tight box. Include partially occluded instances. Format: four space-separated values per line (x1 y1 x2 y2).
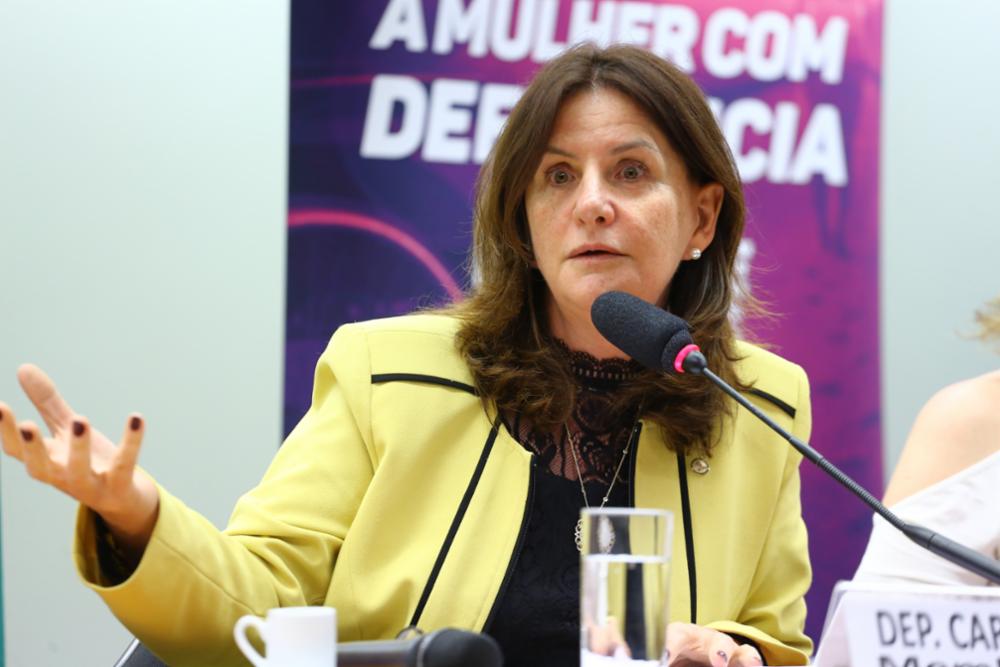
285 0 882 637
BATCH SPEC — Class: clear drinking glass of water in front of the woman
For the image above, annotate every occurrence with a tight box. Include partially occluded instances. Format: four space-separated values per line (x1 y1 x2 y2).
580 507 673 667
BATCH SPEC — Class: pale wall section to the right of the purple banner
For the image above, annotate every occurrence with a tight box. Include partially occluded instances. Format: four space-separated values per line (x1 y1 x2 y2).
881 0 1000 471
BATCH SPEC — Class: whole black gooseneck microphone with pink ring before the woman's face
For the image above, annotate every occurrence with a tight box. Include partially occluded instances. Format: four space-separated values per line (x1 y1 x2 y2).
590 292 1000 584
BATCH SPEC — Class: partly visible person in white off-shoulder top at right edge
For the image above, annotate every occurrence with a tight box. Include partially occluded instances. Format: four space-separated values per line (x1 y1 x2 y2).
854 297 1000 586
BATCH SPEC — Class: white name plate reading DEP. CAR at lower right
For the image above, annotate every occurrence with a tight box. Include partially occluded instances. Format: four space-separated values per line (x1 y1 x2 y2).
813 582 1000 667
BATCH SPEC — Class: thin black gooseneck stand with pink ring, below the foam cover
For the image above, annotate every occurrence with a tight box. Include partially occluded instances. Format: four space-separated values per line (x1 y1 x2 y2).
675 346 1000 584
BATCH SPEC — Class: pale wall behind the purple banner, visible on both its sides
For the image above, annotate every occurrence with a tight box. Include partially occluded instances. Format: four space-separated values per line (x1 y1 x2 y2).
0 0 1000 667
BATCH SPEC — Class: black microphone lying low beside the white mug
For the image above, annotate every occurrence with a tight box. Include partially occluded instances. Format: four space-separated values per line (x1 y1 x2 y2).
337 628 503 667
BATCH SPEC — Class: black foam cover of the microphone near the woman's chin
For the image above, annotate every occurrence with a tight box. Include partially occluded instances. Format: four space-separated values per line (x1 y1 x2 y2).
590 292 693 373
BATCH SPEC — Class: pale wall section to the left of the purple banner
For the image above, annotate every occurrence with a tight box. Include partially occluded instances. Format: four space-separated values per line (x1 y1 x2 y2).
0 0 289 667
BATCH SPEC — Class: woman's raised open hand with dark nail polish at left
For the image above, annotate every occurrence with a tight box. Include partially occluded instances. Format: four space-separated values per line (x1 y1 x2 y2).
0 364 160 563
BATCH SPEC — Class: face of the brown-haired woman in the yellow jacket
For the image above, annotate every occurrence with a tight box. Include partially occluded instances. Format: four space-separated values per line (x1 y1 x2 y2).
525 88 722 346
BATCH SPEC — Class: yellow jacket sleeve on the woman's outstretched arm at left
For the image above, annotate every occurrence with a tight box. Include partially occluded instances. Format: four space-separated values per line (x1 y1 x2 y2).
3 330 374 664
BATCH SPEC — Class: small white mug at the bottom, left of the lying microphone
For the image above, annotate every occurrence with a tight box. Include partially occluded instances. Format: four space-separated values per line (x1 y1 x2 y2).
233 607 337 667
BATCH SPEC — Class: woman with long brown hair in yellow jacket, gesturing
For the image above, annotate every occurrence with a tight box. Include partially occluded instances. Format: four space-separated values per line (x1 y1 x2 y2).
0 46 810 666
